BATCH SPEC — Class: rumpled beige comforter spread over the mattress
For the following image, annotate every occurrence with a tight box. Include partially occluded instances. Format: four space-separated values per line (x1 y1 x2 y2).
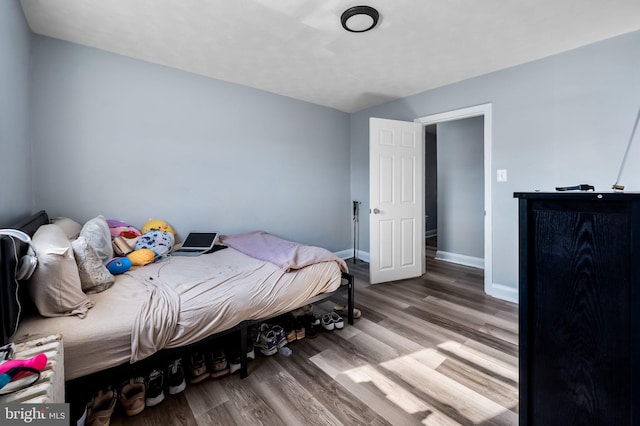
16 248 341 380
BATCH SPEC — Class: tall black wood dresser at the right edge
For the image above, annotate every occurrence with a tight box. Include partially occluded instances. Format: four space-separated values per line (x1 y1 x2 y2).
516 192 640 426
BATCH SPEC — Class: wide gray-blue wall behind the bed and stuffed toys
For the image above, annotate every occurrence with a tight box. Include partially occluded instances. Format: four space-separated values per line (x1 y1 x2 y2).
32 35 351 251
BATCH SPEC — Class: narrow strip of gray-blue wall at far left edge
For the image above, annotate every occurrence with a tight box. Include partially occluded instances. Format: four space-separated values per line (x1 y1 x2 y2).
0 0 33 228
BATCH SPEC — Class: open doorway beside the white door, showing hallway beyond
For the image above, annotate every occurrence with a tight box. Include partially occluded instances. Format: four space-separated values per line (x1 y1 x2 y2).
425 116 484 269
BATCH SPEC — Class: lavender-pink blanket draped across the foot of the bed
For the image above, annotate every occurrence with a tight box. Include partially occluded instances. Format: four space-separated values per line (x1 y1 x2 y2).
221 231 349 272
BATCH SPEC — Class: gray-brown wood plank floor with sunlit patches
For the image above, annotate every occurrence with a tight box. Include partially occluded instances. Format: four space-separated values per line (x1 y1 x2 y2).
111 243 518 426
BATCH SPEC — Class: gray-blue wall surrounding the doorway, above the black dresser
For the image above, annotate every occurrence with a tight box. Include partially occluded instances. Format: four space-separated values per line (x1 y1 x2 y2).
350 32 640 300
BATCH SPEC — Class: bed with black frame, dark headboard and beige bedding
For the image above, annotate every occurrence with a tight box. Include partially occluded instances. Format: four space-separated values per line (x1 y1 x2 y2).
0 211 354 388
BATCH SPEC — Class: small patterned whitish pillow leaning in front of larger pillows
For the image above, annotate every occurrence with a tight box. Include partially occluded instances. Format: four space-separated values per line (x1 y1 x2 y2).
71 237 116 293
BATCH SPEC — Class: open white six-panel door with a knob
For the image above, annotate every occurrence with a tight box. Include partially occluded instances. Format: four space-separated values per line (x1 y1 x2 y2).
369 118 425 284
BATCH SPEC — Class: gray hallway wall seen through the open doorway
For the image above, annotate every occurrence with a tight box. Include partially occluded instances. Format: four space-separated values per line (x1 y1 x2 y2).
437 117 484 259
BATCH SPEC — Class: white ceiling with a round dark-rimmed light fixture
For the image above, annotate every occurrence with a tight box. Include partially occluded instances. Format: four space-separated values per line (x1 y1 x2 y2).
21 0 640 112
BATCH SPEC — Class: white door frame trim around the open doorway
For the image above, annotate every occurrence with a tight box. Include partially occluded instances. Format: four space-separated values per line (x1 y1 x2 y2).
413 103 493 294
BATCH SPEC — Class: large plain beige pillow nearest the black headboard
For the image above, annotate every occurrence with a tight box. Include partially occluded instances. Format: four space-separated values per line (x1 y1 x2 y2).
29 224 93 318
